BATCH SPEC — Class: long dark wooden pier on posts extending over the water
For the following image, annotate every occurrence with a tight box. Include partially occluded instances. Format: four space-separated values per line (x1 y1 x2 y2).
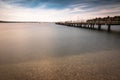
56 16 120 32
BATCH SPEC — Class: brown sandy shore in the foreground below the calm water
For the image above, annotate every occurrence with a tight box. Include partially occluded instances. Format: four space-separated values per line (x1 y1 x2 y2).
0 51 120 80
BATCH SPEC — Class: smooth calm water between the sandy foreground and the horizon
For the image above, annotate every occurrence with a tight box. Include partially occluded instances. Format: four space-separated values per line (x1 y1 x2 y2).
0 23 120 64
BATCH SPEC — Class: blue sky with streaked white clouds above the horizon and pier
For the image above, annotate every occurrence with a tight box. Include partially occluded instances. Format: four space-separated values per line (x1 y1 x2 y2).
0 0 120 22
